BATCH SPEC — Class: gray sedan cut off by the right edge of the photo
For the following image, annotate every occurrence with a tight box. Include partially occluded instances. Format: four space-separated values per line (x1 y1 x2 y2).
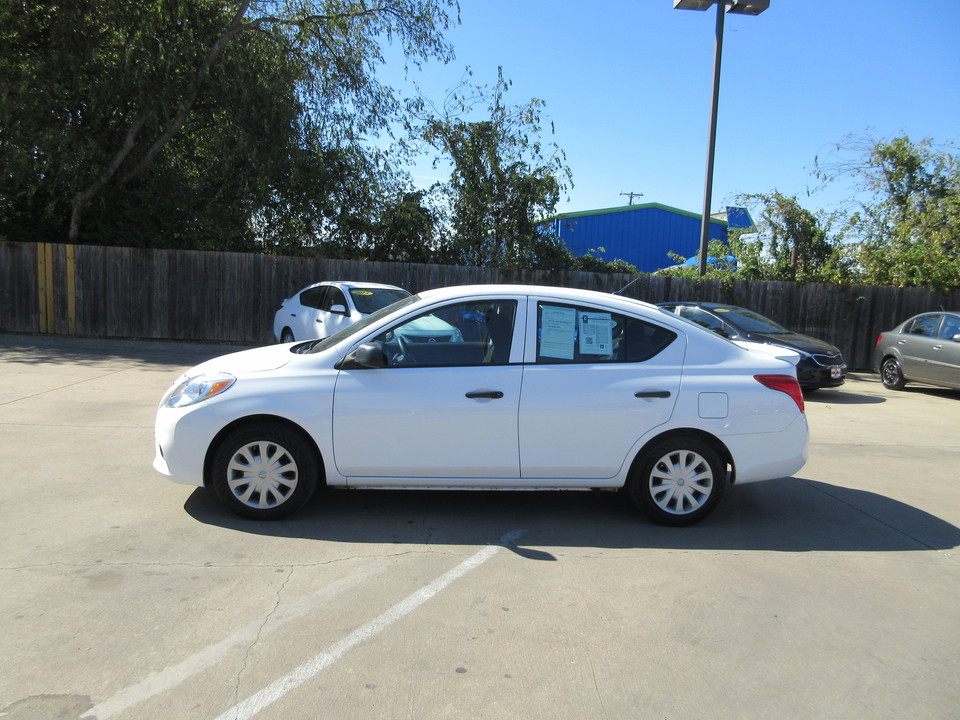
873 312 960 390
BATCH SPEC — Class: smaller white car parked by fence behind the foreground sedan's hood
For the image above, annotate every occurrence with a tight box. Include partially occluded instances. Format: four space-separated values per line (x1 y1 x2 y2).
273 282 410 343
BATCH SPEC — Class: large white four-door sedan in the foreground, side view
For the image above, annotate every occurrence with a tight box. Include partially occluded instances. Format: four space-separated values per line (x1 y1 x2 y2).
154 285 808 525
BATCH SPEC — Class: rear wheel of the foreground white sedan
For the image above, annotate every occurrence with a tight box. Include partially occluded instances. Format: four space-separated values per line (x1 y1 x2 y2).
627 436 727 526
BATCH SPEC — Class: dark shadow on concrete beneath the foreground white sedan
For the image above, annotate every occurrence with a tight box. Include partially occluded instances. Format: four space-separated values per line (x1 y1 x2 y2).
184 478 960 560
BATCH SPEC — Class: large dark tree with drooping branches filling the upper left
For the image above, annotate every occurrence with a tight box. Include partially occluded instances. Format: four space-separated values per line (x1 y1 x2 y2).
0 0 455 248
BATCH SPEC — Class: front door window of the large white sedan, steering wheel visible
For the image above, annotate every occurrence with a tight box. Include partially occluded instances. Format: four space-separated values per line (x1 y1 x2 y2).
374 300 517 367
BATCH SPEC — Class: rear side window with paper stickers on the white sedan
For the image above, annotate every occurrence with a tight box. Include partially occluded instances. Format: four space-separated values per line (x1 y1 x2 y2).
537 303 677 364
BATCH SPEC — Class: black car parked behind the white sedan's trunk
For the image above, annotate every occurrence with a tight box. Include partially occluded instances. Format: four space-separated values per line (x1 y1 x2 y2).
658 302 847 390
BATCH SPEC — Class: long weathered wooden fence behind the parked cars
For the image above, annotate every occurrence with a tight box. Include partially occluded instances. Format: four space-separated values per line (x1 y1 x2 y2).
0 242 960 369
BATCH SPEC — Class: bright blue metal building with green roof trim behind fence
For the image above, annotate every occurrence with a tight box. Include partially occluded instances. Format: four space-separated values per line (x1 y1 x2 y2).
545 203 753 272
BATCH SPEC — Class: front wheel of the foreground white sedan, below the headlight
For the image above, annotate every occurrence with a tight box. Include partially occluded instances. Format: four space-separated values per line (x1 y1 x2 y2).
210 423 320 520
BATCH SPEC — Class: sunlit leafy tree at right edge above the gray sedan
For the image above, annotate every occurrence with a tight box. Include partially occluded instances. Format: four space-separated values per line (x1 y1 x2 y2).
817 136 960 292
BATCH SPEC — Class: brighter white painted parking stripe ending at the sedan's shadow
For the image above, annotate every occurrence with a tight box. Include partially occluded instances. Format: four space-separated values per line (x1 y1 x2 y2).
217 530 526 720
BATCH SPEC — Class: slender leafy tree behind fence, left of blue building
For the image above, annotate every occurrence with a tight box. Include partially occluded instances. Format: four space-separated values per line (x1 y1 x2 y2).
419 70 570 268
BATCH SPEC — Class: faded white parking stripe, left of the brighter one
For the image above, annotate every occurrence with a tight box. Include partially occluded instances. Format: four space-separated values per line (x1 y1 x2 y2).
83 558 390 720
